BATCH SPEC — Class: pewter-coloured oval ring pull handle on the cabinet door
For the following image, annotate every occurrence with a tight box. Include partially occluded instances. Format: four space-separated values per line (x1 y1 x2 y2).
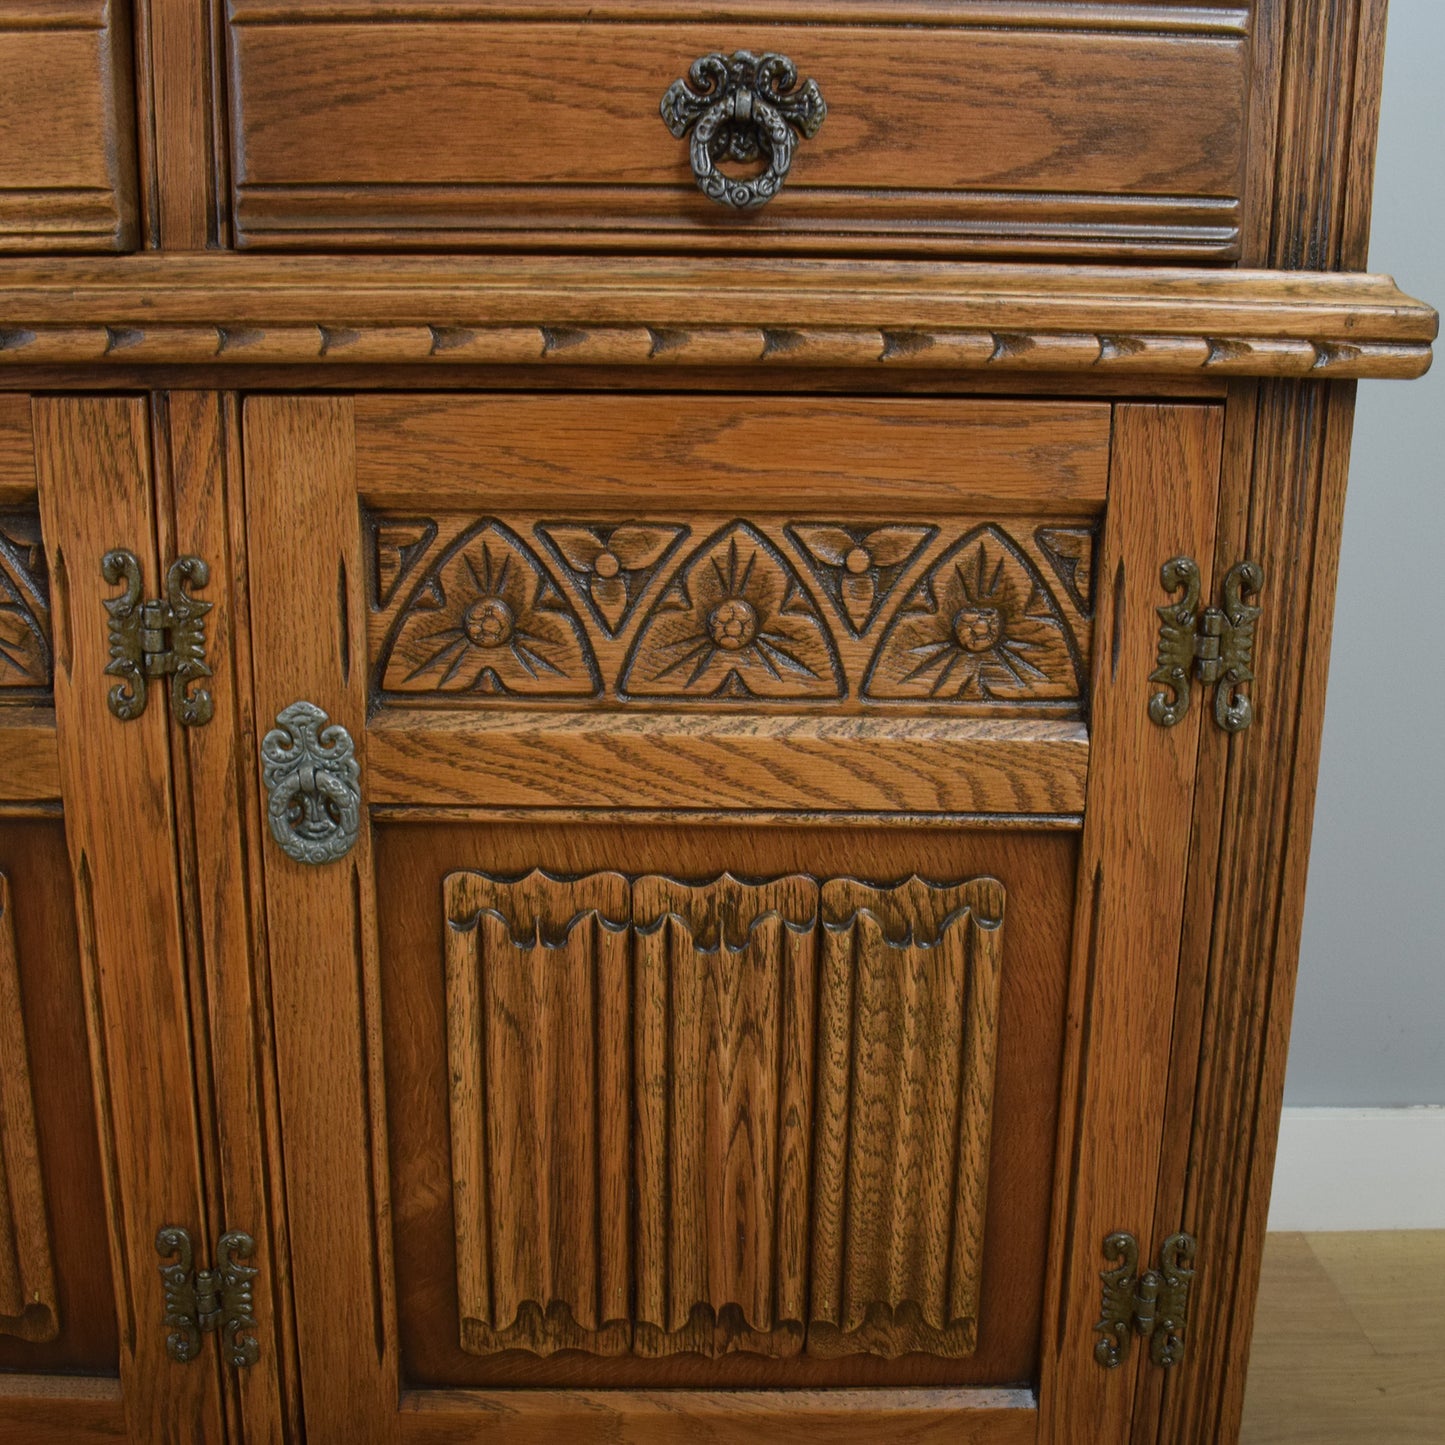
262 702 361 863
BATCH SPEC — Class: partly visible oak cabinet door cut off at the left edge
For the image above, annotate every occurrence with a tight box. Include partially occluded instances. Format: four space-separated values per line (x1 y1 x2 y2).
0 396 224 1445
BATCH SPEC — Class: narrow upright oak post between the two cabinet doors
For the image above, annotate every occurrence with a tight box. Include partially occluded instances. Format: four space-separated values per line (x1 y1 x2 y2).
158 393 295 1445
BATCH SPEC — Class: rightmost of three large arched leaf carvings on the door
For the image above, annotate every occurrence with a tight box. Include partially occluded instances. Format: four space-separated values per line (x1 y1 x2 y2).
864 525 1082 702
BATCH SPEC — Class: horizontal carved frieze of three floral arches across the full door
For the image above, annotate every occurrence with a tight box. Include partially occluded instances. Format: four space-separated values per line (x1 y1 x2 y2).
366 514 1097 717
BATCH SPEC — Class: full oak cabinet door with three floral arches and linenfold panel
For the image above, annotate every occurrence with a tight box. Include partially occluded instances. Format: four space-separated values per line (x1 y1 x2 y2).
243 394 1220 1442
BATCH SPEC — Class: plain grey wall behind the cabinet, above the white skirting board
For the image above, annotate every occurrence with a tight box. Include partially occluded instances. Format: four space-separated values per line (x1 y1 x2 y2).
1285 0 1445 1105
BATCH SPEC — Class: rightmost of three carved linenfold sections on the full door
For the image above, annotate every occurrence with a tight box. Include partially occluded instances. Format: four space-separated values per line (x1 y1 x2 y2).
808 877 1004 1357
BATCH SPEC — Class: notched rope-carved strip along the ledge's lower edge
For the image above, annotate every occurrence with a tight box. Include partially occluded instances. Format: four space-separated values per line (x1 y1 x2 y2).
0 322 1431 380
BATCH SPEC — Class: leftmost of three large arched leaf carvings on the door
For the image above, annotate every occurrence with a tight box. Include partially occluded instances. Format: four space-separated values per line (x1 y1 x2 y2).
381 520 601 698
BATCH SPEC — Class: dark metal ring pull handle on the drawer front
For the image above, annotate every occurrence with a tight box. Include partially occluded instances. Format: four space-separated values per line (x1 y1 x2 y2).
662 51 828 211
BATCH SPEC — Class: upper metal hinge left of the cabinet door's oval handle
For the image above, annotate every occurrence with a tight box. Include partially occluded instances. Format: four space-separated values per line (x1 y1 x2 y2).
100 548 214 727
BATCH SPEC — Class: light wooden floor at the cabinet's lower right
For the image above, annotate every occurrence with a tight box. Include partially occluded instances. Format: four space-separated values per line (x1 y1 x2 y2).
1240 1230 1445 1445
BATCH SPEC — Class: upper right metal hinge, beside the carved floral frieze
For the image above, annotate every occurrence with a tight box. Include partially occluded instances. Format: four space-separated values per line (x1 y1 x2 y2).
1149 556 1264 733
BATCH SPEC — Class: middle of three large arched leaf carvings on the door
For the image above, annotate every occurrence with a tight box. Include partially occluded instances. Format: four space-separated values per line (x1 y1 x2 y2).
621 522 845 699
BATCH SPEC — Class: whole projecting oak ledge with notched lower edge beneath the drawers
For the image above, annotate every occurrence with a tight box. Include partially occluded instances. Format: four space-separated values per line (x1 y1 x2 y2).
0 254 1438 379
